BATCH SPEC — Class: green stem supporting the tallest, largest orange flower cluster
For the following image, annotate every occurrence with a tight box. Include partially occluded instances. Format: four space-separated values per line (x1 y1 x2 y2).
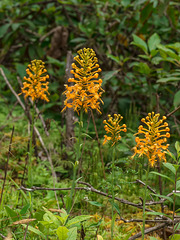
70 109 83 209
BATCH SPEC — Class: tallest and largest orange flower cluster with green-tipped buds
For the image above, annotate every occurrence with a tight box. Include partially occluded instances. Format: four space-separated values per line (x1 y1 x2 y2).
62 48 103 113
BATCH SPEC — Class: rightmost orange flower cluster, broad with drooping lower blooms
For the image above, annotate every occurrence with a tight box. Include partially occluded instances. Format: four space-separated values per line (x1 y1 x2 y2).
132 112 170 166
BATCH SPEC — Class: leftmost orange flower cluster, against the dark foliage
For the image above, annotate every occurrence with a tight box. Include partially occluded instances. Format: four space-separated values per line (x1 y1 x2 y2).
20 60 49 102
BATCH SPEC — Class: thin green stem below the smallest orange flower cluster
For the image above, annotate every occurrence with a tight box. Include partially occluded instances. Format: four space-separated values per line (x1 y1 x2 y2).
111 146 115 239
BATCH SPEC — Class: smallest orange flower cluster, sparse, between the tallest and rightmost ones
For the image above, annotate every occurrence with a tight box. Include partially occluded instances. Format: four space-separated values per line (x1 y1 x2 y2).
103 114 127 146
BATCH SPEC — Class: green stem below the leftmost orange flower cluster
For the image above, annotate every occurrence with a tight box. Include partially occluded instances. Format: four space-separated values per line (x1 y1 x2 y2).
28 102 35 187
